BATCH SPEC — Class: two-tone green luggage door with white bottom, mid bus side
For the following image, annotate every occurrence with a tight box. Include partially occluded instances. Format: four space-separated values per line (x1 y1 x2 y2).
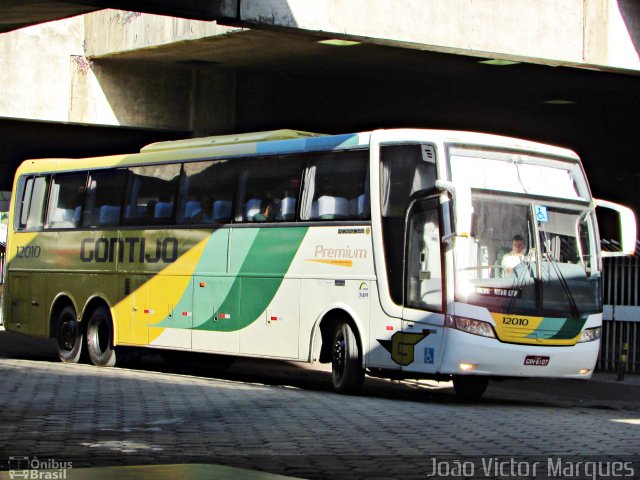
191 276 240 353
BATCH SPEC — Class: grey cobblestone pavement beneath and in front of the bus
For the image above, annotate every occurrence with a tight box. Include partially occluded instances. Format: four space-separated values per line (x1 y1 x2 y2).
0 332 640 479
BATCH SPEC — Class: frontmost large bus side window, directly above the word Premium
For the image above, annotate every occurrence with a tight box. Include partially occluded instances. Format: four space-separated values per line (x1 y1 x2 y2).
300 151 370 220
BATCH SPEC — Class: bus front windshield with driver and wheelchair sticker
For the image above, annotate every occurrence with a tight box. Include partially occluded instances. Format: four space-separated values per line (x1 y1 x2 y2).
455 194 602 318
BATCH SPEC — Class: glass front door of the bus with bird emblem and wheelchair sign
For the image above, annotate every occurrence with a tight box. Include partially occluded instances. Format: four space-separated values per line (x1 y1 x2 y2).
394 197 444 373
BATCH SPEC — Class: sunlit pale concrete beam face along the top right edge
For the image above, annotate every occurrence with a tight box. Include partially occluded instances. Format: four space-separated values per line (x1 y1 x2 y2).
241 0 640 70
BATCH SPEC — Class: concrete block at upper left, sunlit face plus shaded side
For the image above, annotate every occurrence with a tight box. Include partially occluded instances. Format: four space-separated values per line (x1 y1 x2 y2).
0 10 235 134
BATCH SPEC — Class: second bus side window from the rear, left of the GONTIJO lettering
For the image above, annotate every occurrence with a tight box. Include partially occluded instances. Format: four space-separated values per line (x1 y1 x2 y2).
46 172 87 229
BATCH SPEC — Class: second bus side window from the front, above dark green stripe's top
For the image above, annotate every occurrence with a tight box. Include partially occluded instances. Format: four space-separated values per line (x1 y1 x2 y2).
236 156 304 222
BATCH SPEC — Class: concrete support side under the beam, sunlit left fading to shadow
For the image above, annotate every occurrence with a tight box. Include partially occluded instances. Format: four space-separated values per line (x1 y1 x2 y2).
69 57 235 136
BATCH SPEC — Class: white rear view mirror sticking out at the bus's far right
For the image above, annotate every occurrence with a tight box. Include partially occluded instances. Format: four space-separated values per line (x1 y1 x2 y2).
594 199 637 257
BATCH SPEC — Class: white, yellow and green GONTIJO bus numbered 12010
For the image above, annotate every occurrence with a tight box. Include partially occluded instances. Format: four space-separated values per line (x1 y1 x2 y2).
4 129 636 398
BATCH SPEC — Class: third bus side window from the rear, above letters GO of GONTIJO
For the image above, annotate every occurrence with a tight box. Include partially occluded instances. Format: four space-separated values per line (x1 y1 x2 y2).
82 169 130 227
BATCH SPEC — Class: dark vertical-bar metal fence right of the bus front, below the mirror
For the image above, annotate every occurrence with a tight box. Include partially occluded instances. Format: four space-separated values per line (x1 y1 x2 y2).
596 242 640 373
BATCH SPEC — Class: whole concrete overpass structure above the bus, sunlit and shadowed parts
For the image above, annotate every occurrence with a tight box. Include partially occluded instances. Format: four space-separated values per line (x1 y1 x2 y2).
0 0 640 210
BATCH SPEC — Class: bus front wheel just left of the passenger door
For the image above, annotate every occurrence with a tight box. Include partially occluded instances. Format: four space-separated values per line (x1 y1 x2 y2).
331 322 364 393
